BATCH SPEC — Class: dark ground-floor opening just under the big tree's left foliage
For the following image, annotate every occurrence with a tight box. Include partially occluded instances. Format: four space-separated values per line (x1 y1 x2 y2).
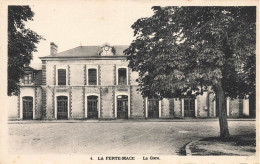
148 98 159 118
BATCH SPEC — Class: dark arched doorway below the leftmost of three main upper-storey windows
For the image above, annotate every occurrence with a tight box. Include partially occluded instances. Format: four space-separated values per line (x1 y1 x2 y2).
57 96 68 120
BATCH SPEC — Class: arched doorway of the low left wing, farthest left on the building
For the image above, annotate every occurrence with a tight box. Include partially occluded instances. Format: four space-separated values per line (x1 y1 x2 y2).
23 96 33 120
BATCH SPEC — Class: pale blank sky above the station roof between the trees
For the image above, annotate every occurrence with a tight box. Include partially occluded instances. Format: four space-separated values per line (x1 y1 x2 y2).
26 1 153 69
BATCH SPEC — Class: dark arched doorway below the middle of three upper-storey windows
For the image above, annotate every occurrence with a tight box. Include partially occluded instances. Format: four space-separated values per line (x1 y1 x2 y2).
87 96 98 119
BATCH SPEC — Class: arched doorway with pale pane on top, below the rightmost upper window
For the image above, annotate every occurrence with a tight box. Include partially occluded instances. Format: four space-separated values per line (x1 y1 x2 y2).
117 95 128 119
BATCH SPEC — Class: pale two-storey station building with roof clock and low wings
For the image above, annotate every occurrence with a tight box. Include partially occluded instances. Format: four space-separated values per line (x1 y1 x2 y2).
14 42 249 120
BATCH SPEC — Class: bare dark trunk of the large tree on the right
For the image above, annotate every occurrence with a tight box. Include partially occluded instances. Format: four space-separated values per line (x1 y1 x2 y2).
217 82 230 139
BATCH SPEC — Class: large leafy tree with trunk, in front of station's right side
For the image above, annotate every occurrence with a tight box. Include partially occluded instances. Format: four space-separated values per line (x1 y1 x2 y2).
124 6 256 138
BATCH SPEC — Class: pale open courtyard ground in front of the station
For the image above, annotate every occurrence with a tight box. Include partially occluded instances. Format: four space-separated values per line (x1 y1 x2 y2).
8 119 256 155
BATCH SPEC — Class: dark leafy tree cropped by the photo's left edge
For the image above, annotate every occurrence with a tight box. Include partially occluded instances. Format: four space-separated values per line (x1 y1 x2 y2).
8 6 43 96
